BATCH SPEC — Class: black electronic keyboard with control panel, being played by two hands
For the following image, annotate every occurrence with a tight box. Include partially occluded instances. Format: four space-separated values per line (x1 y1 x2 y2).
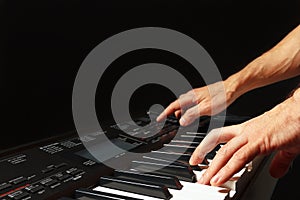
0 113 274 200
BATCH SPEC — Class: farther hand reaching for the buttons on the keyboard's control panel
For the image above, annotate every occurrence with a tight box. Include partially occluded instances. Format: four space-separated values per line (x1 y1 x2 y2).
157 80 238 126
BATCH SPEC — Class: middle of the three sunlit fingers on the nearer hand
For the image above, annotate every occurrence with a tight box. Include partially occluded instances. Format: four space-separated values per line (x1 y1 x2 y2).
199 137 246 184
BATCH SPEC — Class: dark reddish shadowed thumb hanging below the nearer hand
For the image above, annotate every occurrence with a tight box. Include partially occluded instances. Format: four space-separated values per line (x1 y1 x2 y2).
270 150 297 178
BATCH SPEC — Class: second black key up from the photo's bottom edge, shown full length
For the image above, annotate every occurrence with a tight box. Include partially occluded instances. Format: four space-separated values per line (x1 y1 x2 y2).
99 176 172 199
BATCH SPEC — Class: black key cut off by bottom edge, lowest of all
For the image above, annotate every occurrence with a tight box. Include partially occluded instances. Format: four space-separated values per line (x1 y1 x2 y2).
75 188 141 200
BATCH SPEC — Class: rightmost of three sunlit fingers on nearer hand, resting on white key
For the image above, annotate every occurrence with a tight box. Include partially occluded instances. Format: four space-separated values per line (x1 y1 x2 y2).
210 144 258 186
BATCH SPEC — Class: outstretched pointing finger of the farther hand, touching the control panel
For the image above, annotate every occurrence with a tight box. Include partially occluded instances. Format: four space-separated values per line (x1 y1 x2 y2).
156 92 195 122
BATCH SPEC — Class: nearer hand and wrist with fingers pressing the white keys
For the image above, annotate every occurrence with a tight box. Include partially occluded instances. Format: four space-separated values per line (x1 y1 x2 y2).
190 89 300 186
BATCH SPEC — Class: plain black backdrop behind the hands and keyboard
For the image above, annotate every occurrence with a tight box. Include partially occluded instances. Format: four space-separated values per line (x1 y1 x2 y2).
0 0 300 150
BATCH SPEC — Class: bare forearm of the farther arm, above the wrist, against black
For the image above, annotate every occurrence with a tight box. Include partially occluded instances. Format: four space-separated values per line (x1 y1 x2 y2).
224 25 300 99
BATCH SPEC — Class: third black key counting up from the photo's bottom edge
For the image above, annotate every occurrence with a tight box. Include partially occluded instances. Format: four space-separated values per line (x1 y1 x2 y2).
114 170 183 190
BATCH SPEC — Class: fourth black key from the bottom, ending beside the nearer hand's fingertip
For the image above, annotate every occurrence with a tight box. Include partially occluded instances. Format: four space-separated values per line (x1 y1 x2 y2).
132 161 196 182
